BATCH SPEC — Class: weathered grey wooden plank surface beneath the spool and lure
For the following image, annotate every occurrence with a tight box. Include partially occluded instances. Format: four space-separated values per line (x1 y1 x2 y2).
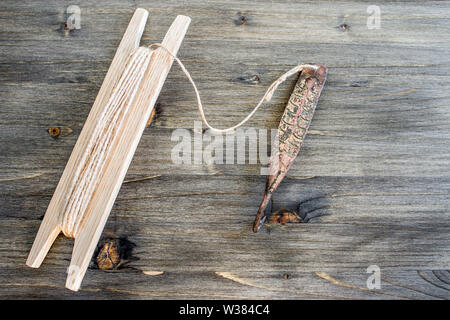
0 0 450 299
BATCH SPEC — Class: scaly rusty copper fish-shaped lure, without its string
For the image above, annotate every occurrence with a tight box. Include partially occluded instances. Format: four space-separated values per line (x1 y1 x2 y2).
253 64 328 232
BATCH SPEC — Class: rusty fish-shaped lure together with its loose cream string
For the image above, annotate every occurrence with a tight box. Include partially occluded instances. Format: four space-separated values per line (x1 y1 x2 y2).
158 55 328 232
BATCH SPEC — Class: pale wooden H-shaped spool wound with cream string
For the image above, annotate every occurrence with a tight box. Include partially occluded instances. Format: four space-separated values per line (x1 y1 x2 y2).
26 9 190 291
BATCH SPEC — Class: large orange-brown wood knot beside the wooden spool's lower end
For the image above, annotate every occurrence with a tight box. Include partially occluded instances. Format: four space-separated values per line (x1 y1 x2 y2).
94 237 137 270
